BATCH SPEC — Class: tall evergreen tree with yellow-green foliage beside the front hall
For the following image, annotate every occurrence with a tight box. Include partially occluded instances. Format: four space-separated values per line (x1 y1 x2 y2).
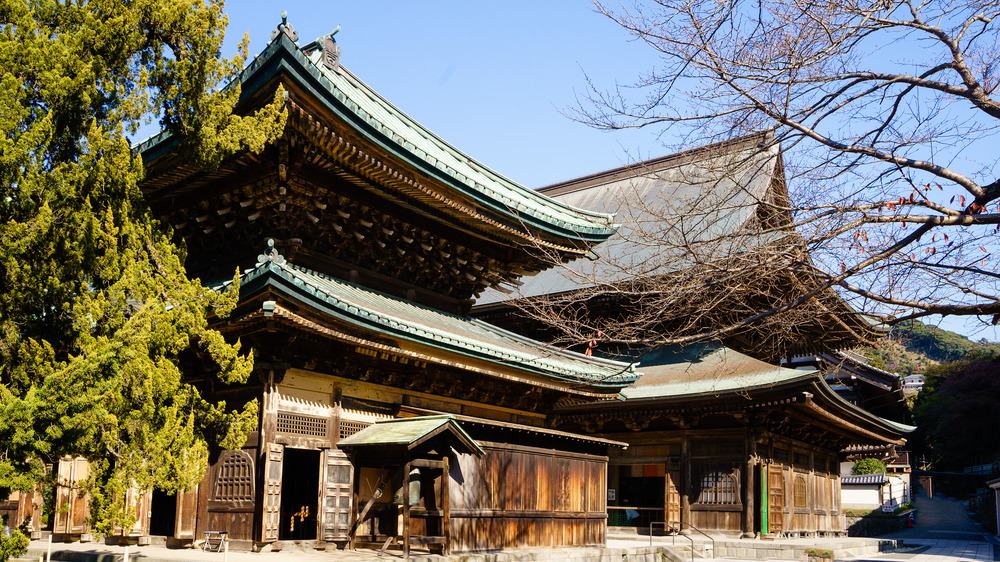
0 0 285 532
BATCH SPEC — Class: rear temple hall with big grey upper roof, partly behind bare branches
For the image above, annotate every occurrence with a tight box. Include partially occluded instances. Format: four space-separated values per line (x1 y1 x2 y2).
473 132 913 537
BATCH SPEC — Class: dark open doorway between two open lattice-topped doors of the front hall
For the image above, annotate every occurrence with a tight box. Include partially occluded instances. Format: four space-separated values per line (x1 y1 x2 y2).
278 448 320 540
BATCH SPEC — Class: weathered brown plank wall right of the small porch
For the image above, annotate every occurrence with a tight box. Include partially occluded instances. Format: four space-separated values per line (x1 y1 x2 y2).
448 443 607 553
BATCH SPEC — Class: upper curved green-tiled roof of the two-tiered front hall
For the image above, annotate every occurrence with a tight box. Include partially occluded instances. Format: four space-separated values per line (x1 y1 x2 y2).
137 35 615 243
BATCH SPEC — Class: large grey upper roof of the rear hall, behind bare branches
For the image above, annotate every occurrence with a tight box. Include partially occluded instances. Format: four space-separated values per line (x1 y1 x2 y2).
477 135 785 305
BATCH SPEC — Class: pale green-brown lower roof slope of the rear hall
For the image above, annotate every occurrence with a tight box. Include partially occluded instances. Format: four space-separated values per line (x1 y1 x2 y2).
621 344 815 401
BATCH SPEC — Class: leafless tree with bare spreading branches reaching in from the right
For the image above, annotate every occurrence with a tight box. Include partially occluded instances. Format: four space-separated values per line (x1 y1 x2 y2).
500 0 1000 356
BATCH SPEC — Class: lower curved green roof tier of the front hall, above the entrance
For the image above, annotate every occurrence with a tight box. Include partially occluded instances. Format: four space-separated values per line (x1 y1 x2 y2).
226 261 637 392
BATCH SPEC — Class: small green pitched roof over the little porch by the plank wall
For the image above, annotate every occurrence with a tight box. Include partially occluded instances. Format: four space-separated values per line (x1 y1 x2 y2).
337 415 486 459
